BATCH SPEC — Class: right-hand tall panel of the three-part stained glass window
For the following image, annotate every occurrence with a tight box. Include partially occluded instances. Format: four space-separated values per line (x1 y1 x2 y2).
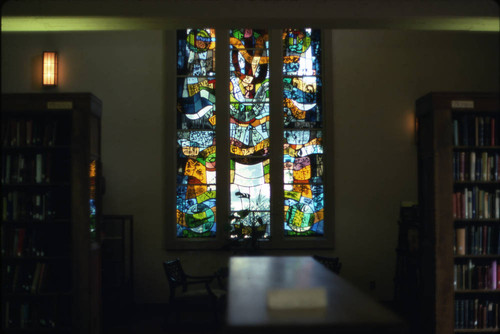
283 29 324 236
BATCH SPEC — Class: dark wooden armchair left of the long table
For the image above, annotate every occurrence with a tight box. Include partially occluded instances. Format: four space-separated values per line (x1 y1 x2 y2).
163 259 225 326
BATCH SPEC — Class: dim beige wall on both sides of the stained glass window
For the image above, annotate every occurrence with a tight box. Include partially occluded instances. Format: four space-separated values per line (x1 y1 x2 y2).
1 30 499 302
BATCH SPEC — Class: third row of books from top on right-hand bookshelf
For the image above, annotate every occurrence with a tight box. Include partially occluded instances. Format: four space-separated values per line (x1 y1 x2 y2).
452 187 500 219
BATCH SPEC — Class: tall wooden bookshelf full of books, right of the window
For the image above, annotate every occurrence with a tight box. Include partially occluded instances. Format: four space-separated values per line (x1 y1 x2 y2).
416 93 500 334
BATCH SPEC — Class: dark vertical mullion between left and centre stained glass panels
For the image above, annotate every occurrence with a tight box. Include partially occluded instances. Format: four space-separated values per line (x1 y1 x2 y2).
215 29 230 240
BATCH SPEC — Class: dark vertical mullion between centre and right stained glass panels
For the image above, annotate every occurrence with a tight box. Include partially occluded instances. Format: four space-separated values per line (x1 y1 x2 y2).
269 29 284 247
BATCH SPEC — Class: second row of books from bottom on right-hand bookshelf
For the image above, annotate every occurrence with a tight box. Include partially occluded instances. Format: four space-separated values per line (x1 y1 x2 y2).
453 260 500 290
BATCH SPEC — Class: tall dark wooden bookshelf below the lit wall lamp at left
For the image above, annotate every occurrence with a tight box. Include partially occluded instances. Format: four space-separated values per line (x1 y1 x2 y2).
0 93 101 333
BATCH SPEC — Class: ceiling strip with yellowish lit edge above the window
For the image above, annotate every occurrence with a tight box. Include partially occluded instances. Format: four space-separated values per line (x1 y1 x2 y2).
2 0 500 33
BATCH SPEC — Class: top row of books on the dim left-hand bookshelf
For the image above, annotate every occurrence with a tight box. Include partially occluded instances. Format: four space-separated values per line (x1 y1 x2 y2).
2 119 65 147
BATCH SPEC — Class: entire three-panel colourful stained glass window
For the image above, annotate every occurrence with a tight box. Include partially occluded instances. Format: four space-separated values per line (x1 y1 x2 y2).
175 28 326 247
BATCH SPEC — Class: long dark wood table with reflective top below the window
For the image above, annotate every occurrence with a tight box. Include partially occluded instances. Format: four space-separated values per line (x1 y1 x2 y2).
225 256 408 334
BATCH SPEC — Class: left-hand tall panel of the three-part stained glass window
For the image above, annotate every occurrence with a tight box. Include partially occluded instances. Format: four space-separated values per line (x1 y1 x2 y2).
177 29 216 238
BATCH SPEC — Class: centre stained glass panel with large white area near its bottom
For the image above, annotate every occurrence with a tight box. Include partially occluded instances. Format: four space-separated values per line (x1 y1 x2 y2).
229 29 271 238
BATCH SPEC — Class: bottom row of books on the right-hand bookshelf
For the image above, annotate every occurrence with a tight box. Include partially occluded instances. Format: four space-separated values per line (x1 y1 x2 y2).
455 298 499 329
